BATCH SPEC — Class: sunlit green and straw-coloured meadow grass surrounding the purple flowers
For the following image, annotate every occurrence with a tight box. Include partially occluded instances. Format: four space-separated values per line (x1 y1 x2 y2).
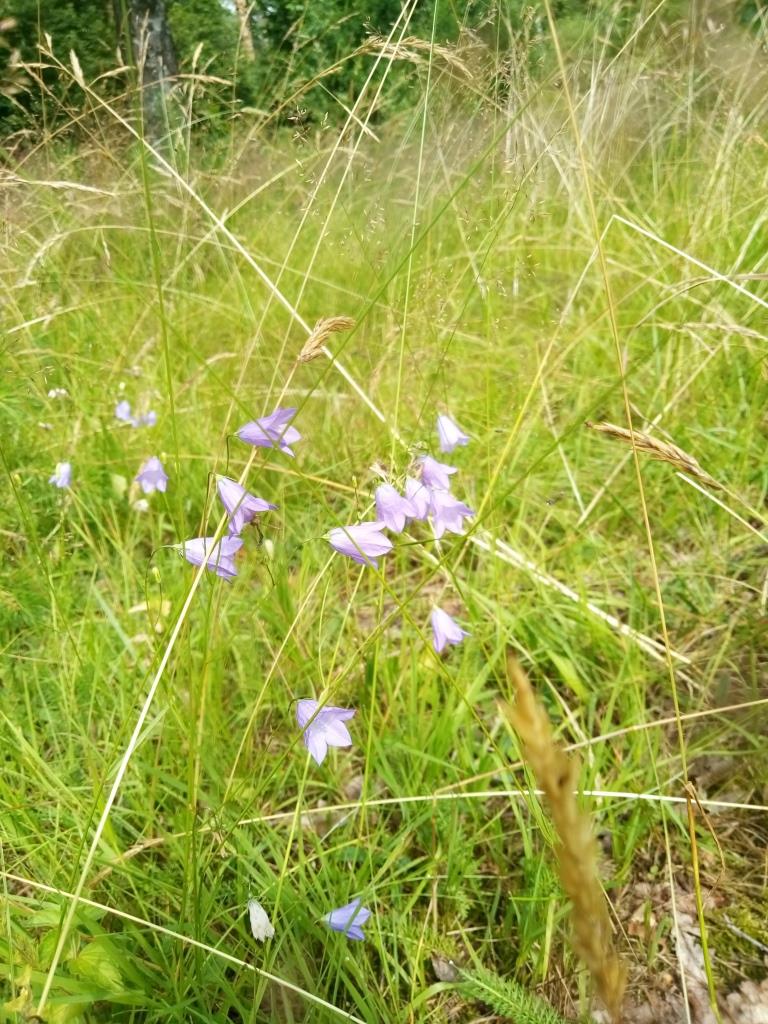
0 8 768 1022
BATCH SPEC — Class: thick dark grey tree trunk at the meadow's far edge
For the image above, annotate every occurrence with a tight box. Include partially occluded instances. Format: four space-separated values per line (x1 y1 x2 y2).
128 0 177 145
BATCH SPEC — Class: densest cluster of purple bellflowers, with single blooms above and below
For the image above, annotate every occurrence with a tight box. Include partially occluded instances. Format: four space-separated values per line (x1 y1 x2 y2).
328 414 474 654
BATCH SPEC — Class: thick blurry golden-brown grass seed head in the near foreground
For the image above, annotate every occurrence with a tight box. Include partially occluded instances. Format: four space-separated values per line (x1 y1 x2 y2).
505 654 627 1021
